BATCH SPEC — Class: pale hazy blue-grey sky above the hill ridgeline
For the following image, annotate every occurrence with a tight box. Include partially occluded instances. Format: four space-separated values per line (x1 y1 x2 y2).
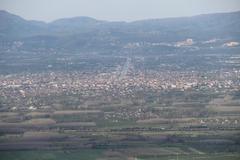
0 0 240 21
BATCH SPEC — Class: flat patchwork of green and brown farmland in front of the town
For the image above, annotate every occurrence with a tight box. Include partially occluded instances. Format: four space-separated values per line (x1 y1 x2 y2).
0 83 240 160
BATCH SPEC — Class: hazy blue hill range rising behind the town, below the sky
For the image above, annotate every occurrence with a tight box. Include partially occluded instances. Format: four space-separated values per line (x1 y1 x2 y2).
0 11 240 50
